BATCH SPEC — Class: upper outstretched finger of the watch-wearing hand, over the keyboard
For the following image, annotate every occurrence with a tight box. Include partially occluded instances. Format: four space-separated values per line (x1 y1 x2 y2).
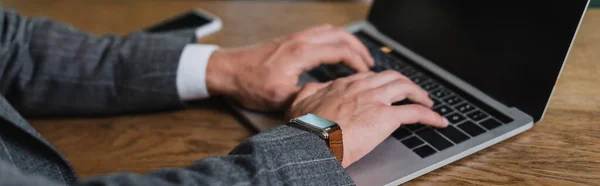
370 80 433 108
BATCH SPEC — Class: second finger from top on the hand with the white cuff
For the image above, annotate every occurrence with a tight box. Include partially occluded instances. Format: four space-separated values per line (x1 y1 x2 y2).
290 43 369 72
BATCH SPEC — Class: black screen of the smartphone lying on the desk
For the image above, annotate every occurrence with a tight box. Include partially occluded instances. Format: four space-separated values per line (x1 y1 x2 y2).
146 12 212 33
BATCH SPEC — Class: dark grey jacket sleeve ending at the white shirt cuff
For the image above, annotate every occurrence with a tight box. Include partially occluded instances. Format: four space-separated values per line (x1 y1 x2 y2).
0 7 190 116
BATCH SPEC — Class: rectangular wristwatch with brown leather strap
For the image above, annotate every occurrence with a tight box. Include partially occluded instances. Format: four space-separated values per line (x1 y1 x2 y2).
289 113 344 163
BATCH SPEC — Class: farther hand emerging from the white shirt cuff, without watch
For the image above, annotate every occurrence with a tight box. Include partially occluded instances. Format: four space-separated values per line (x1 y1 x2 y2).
206 25 374 111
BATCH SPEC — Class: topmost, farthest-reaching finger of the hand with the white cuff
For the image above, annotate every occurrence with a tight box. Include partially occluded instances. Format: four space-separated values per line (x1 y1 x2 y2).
296 28 375 67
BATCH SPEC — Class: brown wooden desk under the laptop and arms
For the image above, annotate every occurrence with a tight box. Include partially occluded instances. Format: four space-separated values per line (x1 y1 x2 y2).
0 0 600 185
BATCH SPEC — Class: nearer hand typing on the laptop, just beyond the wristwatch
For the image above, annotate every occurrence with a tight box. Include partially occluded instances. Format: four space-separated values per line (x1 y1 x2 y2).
288 71 448 168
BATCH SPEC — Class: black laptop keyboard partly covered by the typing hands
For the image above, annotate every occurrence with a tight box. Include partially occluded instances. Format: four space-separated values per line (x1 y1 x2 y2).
308 33 509 158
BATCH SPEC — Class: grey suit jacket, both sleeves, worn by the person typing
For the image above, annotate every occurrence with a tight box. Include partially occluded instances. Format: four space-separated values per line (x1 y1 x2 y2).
0 7 353 186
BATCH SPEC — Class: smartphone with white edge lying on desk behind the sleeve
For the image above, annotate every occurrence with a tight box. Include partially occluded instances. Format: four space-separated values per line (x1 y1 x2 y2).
144 9 223 40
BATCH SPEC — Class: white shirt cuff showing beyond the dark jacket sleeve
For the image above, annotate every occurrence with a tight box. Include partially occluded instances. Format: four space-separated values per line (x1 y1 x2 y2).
177 44 219 101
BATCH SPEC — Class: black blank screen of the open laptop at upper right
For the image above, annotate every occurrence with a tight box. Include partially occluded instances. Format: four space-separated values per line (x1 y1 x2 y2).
368 0 587 122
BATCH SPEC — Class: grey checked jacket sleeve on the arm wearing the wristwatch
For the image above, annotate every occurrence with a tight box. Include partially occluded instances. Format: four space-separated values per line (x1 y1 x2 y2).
0 126 354 186
